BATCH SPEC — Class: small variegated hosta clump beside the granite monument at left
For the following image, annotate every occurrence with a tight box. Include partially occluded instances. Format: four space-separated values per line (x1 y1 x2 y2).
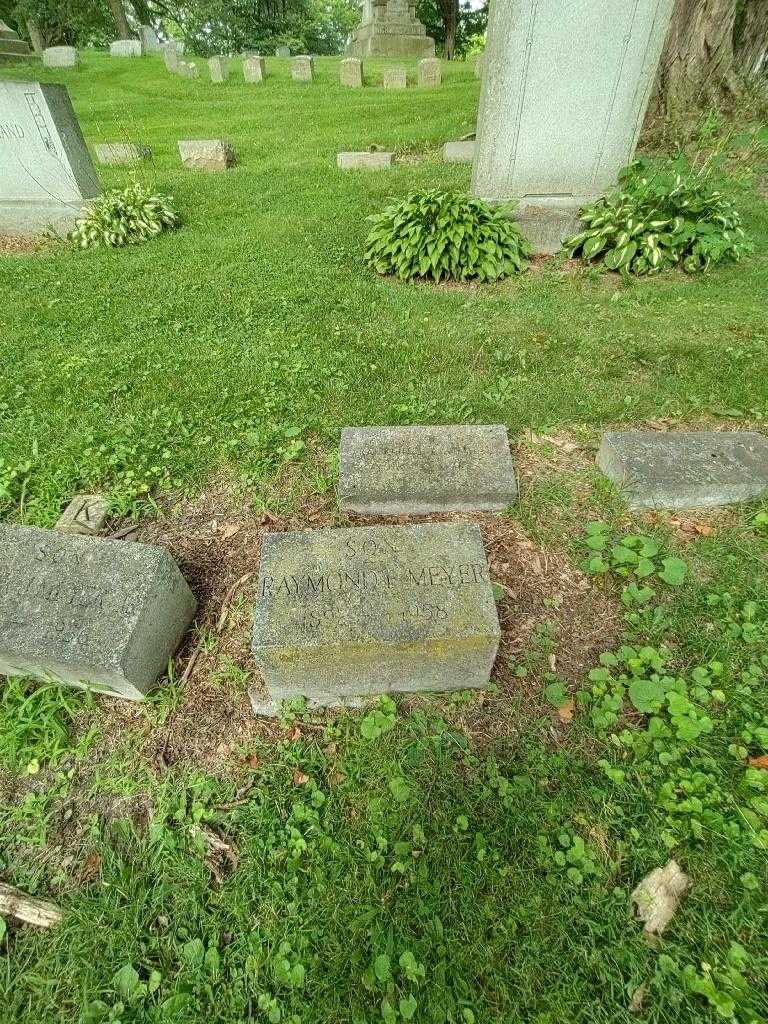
70 182 179 249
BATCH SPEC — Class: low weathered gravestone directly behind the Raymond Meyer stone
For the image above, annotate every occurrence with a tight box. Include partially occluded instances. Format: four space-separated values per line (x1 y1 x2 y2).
339 425 517 515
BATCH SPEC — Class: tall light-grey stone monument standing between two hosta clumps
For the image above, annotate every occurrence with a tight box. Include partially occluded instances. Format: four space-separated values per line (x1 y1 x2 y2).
472 0 674 252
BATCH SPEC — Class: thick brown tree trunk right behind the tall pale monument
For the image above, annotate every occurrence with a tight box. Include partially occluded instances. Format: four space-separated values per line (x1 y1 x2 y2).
656 0 737 112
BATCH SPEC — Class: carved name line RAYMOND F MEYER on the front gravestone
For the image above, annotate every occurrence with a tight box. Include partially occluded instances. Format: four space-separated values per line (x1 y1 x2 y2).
261 562 489 597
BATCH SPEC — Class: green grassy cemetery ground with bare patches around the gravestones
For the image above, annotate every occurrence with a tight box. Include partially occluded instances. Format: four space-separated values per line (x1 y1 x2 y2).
0 55 768 1024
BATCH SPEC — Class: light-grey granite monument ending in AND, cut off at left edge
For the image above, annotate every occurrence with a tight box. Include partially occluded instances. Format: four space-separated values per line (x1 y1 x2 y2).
0 81 101 234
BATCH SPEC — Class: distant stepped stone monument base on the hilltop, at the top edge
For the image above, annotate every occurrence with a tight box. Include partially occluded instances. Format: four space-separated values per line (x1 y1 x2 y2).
346 0 434 57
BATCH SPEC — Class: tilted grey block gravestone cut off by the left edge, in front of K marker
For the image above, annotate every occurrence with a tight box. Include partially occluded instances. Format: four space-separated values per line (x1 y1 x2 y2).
0 524 196 700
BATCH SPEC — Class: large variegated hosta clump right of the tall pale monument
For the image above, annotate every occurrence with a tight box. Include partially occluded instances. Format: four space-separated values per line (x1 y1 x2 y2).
565 160 752 274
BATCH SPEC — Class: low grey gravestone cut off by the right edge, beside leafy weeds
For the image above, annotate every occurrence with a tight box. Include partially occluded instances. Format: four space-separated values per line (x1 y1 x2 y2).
597 430 768 509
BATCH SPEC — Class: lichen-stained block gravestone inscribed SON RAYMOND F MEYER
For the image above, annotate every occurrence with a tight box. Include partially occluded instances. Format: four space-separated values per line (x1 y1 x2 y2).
253 523 500 705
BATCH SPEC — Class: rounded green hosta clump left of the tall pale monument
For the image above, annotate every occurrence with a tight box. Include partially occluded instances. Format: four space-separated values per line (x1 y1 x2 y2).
365 188 530 283
